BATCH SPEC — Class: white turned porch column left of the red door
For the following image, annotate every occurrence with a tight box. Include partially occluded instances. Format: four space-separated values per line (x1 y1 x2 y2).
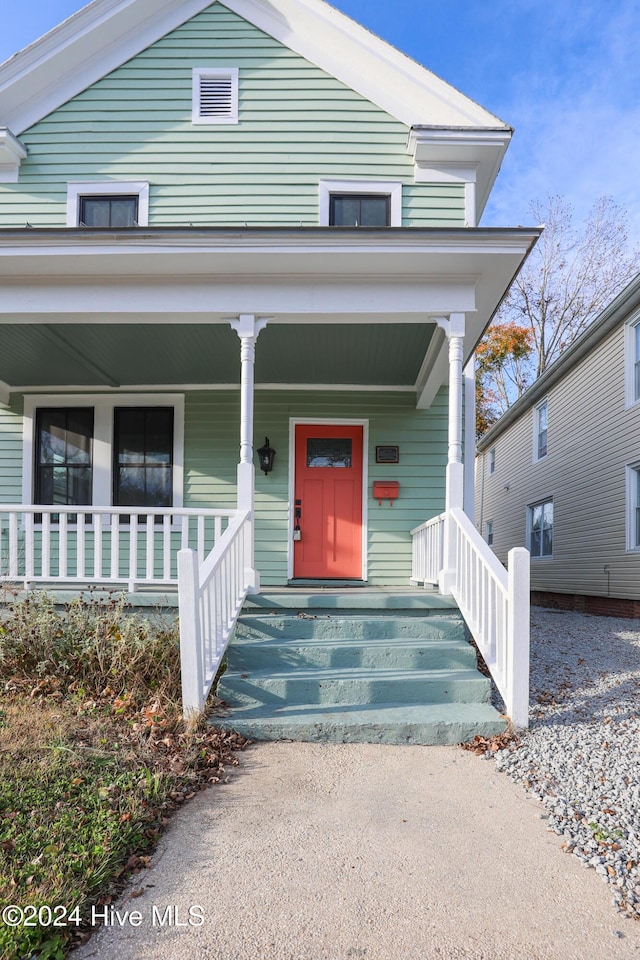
229 313 267 593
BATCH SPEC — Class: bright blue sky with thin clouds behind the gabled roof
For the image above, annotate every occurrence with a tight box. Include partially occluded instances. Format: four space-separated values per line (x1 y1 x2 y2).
0 0 640 242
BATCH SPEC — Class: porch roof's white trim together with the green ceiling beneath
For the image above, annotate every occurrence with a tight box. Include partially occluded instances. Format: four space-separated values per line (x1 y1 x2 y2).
0 227 540 405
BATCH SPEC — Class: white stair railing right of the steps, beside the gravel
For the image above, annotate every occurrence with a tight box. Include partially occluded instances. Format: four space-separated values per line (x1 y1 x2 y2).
412 509 529 728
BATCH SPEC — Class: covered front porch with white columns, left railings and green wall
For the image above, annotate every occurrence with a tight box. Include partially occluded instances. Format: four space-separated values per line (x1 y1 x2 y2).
0 228 537 709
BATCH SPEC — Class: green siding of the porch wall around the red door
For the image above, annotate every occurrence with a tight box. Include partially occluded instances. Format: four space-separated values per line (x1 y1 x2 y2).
0 388 447 586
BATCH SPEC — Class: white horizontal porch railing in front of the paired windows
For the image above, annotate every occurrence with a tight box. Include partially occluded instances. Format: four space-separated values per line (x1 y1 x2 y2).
0 504 237 592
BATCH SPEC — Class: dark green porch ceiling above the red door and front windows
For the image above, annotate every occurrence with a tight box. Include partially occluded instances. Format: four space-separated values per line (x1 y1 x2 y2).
0 323 434 388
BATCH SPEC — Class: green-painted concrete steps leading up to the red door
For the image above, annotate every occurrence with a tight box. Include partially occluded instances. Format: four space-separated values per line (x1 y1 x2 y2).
214 590 505 744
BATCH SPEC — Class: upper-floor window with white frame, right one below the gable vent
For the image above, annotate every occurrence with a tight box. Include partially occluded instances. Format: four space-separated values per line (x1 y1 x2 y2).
318 180 402 227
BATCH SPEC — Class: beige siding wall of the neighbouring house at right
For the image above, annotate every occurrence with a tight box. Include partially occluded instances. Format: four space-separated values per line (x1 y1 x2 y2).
476 324 640 600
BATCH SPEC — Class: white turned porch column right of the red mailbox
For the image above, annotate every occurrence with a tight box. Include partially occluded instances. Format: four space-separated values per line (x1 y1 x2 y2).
438 313 465 596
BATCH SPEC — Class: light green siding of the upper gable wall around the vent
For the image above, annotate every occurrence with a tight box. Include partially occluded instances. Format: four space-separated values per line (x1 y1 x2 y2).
0 4 464 227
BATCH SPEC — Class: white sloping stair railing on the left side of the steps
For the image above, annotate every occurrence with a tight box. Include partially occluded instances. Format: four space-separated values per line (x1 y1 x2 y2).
178 510 253 719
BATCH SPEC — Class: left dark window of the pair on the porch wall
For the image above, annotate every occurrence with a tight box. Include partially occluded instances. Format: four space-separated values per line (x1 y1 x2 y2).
34 407 93 506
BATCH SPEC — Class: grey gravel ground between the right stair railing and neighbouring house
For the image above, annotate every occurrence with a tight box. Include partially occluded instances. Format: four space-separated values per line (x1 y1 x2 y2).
487 607 640 918
